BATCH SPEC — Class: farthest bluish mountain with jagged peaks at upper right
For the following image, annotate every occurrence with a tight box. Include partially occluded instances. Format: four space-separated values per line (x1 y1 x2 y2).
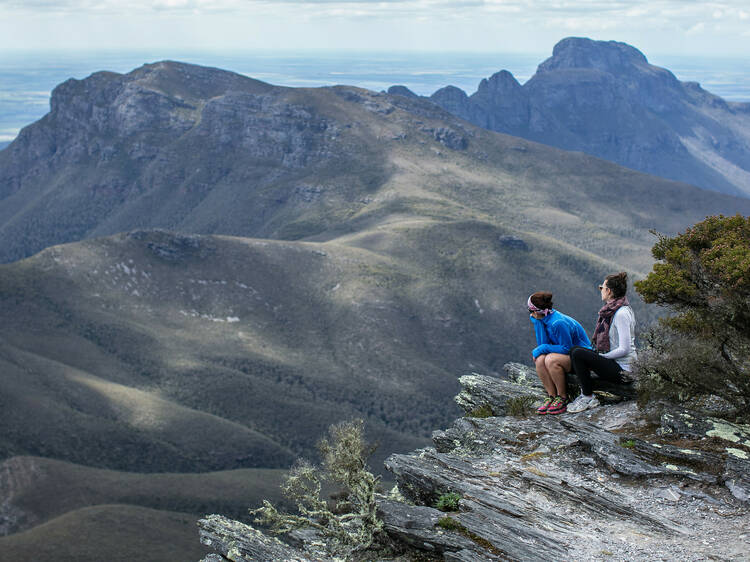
389 37 750 197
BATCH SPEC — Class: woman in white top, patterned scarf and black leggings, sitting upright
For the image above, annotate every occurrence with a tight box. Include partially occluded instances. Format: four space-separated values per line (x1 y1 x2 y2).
568 271 637 413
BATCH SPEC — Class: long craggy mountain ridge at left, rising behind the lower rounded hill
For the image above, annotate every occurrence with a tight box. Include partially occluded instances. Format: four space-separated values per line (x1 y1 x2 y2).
5 58 750 268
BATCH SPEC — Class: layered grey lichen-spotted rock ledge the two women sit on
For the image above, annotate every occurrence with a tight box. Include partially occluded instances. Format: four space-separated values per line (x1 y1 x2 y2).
199 364 750 562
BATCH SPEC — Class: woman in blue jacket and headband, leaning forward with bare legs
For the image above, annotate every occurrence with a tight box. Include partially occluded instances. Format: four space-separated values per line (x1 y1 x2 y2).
526 291 591 414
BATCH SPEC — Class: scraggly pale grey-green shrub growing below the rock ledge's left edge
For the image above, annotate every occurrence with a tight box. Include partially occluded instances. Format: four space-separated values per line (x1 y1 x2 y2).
250 420 382 557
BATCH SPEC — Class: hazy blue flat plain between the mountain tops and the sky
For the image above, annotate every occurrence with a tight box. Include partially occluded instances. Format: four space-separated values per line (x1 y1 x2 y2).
0 45 750 143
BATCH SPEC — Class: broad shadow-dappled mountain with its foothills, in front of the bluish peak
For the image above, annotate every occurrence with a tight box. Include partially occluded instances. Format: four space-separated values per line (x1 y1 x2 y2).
0 46 750 560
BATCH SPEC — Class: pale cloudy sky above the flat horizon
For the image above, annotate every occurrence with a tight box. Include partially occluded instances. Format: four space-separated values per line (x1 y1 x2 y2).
0 0 750 57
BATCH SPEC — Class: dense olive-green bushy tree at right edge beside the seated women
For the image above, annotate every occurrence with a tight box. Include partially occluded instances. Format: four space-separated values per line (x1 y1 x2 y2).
635 215 750 411
